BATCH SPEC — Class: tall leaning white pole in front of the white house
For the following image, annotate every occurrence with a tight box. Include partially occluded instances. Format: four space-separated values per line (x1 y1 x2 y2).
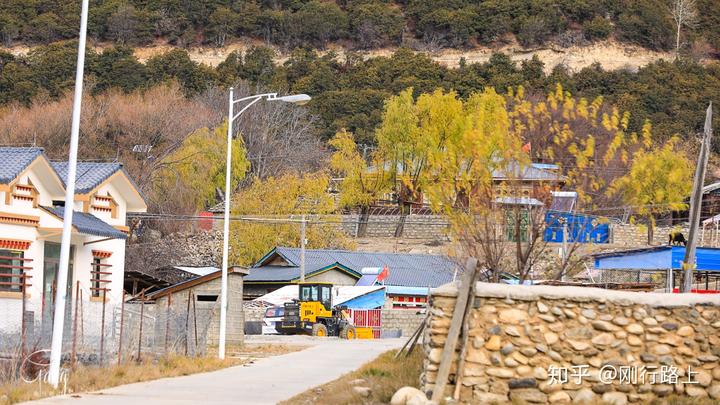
48 0 88 388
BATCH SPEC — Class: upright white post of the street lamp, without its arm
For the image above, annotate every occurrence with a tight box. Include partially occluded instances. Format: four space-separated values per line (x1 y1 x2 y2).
218 87 233 360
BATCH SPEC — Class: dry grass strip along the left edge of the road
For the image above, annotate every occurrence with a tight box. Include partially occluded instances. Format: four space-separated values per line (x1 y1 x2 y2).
0 344 303 405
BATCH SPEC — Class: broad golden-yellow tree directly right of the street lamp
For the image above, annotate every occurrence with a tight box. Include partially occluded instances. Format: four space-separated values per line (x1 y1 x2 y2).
230 173 353 266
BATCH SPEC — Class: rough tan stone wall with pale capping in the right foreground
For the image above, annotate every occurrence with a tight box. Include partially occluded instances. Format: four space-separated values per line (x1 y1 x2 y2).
421 283 720 404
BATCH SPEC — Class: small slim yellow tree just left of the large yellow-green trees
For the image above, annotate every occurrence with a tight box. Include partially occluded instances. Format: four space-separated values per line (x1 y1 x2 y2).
330 130 391 236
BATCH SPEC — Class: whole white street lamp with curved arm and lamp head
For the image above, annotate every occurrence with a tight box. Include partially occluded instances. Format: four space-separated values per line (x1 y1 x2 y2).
218 87 310 359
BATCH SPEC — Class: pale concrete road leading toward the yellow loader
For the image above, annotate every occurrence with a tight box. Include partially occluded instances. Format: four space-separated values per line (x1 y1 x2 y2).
31 338 405 405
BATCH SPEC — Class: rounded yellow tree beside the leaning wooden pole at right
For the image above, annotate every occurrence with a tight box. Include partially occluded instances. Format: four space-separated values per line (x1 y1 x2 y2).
609 138 693 245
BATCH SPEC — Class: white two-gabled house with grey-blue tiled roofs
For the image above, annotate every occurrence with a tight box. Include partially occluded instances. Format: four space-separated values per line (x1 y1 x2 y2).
0 147 147 331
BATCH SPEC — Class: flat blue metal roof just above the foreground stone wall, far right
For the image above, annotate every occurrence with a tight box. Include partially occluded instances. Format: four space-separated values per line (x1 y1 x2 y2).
594 246 720 271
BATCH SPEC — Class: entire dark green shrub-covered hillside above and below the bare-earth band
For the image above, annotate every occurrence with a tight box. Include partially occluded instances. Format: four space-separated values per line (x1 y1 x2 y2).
0 0 720 148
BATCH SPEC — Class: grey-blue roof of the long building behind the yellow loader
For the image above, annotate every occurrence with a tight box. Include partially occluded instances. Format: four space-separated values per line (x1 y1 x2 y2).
245 247 462 288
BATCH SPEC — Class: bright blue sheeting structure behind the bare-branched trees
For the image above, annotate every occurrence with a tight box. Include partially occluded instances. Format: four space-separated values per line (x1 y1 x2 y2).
544 211 610 243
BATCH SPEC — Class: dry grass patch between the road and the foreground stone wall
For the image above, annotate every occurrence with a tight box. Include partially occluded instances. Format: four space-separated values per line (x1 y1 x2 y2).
281 348 422 405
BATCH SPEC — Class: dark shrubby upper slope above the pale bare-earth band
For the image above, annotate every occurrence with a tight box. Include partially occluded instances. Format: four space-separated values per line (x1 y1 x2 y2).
0 0 720 53
